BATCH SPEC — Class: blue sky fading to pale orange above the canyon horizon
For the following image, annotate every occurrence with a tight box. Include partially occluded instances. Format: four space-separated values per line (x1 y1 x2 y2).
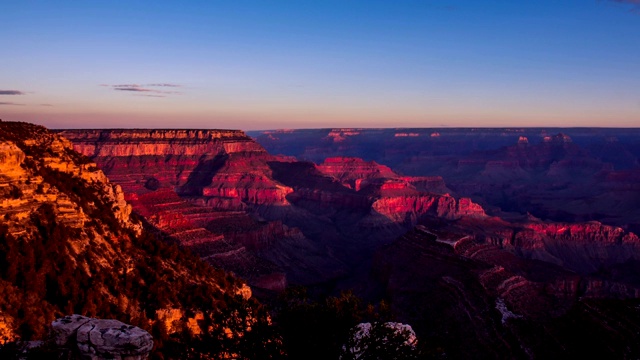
0 0 640 130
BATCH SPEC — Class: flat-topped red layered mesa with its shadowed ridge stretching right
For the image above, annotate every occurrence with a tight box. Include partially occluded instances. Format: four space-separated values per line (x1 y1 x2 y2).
60 129 485 290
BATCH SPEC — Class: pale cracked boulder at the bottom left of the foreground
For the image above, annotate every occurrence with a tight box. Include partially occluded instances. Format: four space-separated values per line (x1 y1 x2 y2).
51 315 153 360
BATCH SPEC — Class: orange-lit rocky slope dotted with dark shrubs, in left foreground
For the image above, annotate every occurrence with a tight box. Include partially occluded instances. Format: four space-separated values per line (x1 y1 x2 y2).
0 122 277 358
